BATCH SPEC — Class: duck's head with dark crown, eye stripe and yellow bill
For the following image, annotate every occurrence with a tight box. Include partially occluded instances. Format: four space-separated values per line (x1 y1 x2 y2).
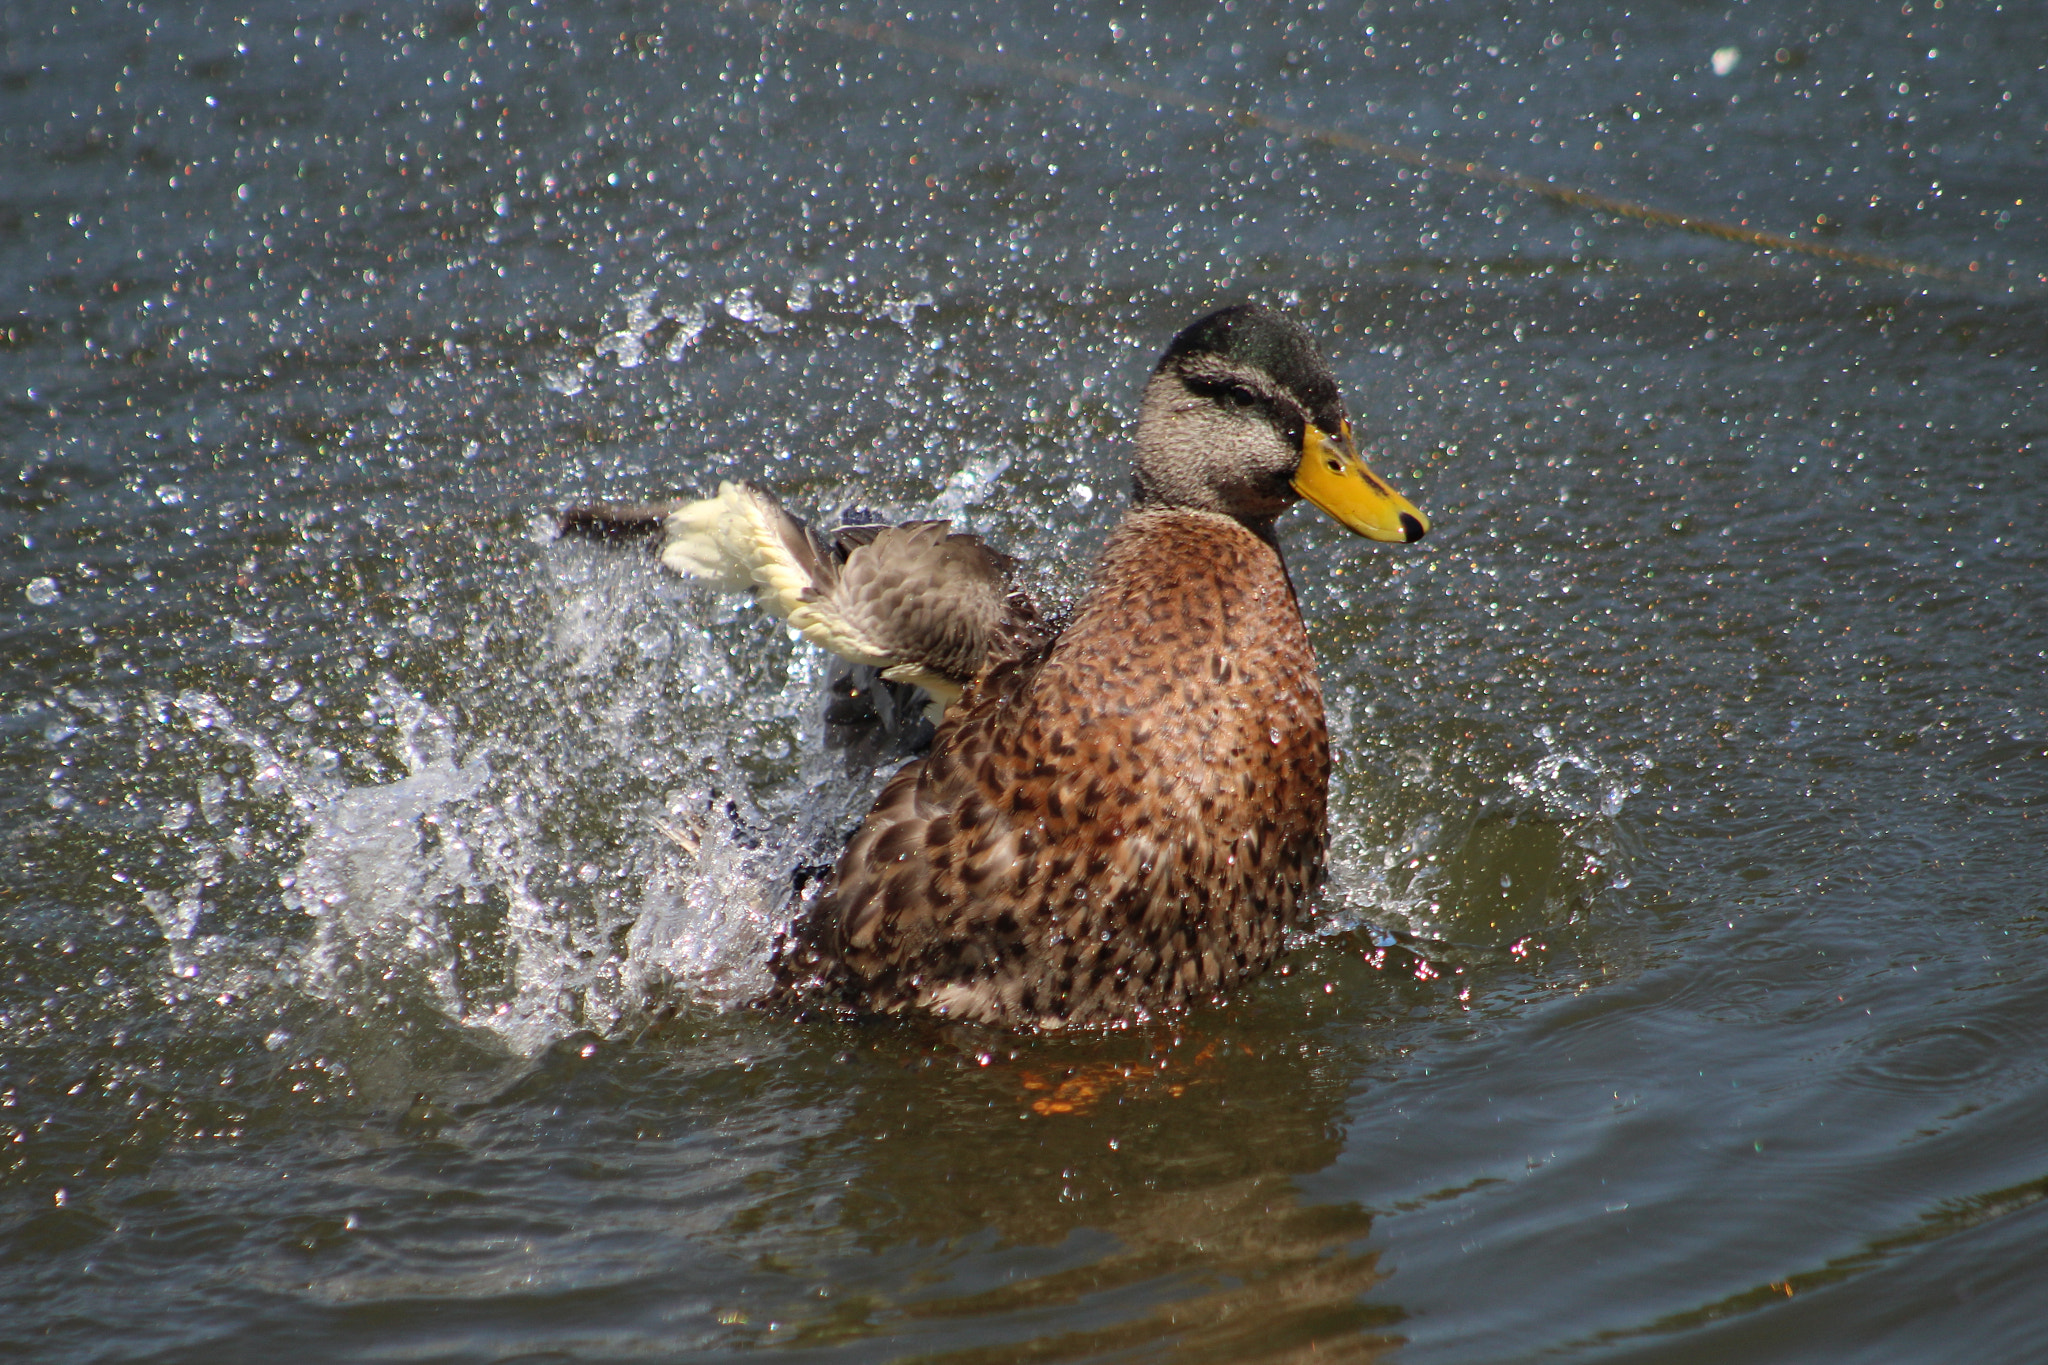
1133 303 1430 542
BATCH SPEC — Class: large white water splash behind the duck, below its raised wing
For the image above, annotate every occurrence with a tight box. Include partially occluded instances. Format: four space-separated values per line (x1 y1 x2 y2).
141 523 929 1056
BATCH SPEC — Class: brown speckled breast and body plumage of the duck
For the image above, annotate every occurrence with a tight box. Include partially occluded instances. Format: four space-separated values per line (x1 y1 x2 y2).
776 510 1329 1025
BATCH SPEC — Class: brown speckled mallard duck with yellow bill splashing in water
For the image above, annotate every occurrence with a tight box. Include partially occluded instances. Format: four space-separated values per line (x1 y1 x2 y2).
563 305 1430 1027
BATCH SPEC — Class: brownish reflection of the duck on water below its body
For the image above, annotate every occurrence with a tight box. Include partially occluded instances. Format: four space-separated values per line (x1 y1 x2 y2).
700 1023 1401 1361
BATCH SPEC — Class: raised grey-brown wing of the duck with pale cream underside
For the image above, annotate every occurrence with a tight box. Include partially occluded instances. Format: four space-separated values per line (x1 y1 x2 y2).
561 483 1042 706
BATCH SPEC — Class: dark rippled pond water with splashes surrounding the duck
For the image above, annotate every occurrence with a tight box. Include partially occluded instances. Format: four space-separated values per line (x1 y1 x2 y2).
0 0 2048 1365
